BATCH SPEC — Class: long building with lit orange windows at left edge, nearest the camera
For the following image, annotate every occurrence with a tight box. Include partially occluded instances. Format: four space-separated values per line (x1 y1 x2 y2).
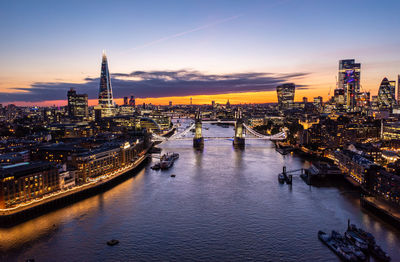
0 162 60 208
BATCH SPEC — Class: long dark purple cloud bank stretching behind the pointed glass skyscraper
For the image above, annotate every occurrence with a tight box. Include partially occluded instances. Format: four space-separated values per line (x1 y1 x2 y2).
0 70 308 102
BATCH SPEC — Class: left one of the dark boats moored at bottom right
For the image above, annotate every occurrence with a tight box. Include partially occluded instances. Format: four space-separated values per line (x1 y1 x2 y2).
318 230 359 262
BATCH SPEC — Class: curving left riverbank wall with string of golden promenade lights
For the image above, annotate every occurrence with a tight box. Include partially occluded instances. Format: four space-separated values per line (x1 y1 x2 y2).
0 145 152 227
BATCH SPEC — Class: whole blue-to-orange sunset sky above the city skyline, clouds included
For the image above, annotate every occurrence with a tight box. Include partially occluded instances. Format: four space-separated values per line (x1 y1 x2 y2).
0 0 400 105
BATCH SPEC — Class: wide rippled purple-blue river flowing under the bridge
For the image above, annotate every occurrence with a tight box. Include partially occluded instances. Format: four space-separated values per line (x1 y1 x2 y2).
0 124 400 261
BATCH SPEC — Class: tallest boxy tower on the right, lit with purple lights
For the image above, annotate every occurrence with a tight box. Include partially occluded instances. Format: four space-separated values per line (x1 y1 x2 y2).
338 59 361 111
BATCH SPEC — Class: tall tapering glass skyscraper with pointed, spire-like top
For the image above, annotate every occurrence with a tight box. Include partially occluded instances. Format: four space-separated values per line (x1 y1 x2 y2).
99 52 114 117
